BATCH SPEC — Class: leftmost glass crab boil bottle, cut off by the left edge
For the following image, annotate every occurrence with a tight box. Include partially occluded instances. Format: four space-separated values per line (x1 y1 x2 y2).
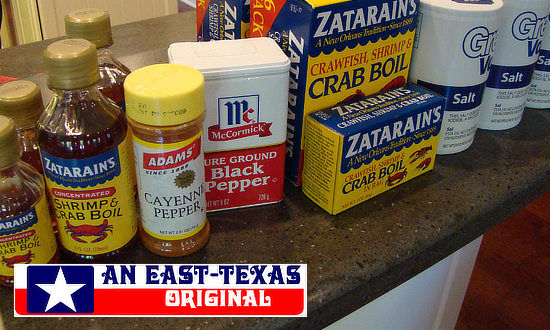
0 116 59 286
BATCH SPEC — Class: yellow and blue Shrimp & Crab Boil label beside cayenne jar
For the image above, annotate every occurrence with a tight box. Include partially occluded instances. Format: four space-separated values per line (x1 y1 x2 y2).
40 134 137 255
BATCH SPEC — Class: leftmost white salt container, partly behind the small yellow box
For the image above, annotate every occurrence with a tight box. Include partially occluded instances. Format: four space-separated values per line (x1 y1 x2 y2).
409 0 502 155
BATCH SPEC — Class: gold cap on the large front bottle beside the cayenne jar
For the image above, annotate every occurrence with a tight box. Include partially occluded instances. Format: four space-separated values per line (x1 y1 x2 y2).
44 39 99 89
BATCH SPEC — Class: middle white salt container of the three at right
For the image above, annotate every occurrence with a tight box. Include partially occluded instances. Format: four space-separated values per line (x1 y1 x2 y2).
479 0 550 130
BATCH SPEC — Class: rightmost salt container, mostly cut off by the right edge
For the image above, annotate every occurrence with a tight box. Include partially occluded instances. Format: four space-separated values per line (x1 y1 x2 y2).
525 26 550 109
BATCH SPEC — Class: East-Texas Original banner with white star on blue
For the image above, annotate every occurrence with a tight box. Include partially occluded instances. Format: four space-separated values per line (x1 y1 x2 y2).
14 264 307 317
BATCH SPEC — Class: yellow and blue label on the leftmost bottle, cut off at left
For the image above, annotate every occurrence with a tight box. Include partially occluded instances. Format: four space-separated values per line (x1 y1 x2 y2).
0 195 57 276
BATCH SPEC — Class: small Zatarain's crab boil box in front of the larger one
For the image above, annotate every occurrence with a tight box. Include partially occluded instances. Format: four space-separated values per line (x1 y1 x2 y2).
302 83 445 214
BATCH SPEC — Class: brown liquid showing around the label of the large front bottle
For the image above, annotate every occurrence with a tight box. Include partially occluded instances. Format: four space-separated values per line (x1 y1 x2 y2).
38 87 137 261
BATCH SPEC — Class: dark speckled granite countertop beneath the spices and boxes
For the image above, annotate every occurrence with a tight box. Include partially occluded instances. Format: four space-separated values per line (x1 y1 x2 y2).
0 12 550 328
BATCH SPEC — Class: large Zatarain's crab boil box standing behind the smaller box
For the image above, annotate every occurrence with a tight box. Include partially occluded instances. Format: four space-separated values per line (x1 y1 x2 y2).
250 0 419 185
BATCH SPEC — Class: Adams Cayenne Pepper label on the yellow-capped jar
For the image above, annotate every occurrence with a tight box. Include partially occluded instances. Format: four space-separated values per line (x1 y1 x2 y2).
134 131 206 240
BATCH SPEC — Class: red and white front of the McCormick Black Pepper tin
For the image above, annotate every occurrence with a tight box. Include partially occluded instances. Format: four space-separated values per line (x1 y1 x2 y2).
203 91 286 211
